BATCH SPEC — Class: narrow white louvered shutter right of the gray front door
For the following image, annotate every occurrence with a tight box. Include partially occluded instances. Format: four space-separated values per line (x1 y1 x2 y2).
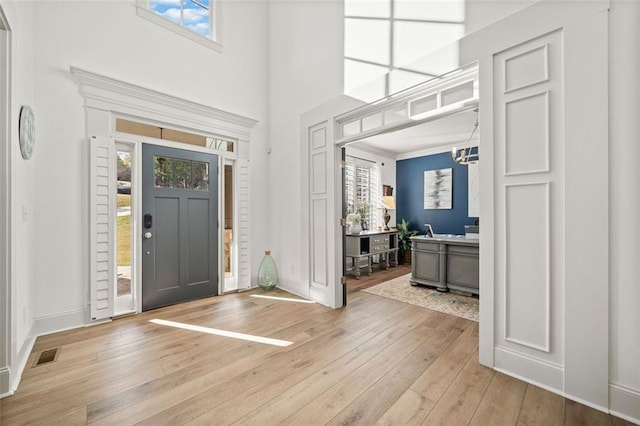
237 159 251 290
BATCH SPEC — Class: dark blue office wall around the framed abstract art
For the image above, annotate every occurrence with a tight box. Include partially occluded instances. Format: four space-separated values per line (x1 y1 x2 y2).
396 152 477 234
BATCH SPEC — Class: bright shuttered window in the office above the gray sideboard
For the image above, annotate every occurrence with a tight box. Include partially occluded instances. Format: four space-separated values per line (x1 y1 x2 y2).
345 156 381 229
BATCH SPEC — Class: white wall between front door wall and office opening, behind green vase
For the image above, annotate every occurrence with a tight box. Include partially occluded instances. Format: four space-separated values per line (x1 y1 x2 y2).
266 0 344 296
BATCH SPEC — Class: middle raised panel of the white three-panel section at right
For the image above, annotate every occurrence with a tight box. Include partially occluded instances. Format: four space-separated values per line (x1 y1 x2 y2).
504 92 549 176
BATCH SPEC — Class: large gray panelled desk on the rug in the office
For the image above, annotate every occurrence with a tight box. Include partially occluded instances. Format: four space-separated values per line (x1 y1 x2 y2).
411 235 480 294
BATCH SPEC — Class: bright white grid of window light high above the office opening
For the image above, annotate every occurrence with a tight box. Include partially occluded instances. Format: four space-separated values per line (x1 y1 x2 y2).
344 0 465 99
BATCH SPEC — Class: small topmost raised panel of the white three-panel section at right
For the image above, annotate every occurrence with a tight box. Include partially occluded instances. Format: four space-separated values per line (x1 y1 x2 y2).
504 45 549 93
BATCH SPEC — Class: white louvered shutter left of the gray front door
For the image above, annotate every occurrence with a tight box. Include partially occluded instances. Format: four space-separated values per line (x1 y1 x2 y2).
89 136 116 320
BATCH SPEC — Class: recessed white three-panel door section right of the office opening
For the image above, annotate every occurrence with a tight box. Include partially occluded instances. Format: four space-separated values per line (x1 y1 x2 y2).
493 31 564 387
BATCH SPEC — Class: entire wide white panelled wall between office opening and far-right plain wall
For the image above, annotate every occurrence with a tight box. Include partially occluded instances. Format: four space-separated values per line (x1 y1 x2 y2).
476 2 609 410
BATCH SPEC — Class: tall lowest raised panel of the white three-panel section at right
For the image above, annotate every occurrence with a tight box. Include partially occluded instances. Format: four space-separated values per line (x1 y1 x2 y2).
501 182 551 352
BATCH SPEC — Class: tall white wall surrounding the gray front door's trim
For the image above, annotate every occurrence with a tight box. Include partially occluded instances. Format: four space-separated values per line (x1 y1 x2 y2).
25 1 268 326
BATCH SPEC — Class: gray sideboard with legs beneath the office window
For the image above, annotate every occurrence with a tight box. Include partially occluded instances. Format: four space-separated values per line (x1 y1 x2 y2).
345 231 398 278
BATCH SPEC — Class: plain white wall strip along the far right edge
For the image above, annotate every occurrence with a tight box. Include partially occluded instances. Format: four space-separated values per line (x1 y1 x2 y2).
609 0 640 421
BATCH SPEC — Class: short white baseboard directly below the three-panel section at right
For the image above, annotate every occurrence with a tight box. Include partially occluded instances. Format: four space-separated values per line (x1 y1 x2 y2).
494 346 564 393
